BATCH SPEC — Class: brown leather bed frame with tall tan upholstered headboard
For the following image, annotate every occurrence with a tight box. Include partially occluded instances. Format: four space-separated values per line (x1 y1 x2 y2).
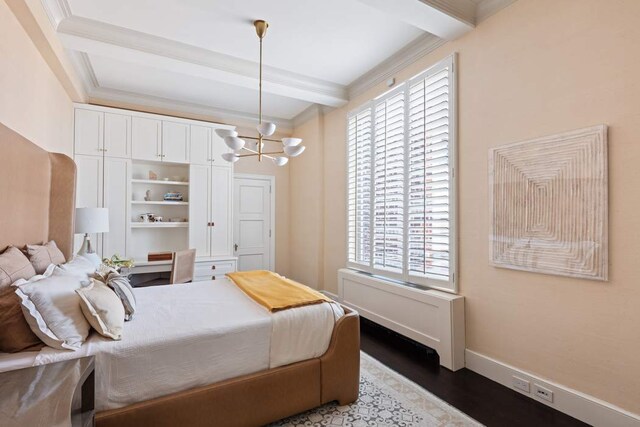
0 124 360 427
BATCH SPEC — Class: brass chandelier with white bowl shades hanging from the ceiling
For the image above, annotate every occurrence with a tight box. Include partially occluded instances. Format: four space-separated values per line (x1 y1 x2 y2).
216 20 305 166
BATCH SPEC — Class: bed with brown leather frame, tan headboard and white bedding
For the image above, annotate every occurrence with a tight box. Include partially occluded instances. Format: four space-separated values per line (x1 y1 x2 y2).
0 125 360 426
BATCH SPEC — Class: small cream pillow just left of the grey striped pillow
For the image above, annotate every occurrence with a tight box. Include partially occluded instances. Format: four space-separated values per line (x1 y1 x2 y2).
76 279 124 340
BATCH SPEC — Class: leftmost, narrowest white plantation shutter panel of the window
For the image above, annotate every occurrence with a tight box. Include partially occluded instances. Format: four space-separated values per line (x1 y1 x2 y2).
347 108 372 267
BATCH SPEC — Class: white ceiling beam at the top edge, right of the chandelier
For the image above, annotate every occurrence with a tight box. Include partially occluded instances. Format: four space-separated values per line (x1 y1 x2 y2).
360 0 476 40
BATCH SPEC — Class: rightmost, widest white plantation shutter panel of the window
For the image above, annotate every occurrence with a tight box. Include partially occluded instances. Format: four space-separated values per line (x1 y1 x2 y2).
407 67 451 281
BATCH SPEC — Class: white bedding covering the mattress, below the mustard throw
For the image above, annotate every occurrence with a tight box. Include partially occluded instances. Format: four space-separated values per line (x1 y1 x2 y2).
0 279 344 411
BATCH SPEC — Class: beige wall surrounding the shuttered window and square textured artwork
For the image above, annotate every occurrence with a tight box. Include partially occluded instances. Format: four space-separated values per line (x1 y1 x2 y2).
291 0 640 413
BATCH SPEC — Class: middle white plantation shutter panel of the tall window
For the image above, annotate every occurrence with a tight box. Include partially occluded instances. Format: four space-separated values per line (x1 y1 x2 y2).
373 91 405 274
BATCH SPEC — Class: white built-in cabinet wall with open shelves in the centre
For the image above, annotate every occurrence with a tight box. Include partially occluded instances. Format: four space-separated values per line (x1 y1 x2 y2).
74 104 236 279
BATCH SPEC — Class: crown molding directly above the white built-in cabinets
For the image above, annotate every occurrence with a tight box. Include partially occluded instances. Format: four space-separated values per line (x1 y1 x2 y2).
89 86 293 133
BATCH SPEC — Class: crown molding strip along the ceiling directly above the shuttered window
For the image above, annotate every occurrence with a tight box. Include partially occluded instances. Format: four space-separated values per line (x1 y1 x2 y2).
347 33 447 99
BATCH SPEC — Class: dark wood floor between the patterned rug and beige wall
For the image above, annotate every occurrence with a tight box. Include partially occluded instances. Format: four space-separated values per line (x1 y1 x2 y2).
360 319 587 427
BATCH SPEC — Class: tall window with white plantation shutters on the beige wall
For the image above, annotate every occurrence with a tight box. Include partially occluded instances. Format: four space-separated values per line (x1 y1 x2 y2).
347 57 455 291
